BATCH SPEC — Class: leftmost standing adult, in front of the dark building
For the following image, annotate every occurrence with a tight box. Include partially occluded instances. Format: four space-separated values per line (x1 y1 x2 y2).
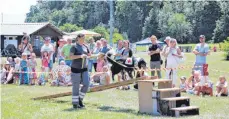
18 36 33 57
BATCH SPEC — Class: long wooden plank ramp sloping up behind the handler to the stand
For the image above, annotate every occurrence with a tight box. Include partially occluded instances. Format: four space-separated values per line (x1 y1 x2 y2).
32 78 143 100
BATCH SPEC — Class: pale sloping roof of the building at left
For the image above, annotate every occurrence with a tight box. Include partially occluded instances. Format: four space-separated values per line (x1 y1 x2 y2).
0 22 64 35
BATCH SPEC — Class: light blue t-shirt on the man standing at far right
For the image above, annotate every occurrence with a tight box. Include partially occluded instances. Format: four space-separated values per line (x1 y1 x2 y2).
195 43 209 64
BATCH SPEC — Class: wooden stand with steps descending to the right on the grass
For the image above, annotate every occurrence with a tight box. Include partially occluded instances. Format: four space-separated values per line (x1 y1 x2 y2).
138 79 199 117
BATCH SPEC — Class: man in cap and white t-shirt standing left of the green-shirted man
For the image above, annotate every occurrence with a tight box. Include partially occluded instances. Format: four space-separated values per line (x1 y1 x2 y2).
41 37 54 71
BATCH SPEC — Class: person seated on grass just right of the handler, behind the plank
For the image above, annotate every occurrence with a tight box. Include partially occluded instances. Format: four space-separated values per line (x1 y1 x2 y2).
91 65 111 86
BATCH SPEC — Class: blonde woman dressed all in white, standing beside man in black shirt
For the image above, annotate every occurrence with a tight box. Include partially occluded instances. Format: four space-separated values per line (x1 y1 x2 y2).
165 38 183 87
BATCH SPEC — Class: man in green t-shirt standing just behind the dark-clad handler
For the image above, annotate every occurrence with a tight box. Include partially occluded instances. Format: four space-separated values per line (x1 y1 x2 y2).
62 38 72 66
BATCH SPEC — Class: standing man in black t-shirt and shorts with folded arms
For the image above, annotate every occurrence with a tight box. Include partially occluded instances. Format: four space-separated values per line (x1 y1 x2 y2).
148 35 161 78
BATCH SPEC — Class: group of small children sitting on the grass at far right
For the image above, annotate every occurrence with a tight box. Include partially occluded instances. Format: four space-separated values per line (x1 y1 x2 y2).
180 71 229 97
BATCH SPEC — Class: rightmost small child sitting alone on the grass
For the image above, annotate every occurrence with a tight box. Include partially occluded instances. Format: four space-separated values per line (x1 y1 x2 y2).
216 76 228 97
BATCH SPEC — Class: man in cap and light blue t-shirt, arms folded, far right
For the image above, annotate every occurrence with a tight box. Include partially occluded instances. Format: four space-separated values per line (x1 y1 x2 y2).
193 35 210 75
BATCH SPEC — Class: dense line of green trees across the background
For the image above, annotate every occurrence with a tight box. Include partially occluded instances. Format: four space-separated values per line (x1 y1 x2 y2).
25 0 229 43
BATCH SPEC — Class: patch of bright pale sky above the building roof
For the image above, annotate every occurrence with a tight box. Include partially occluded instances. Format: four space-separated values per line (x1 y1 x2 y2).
0 0 37 23
